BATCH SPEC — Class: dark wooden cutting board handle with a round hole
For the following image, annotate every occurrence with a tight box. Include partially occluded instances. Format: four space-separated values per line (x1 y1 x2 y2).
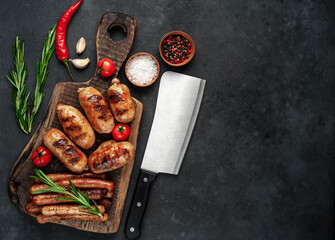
90 13 136 86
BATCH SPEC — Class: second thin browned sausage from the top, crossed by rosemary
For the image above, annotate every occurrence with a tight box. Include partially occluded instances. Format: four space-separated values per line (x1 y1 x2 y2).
30 178 114 194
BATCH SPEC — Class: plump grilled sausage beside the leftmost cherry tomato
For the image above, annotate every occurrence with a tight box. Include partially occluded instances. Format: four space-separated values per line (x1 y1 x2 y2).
43 128 87 173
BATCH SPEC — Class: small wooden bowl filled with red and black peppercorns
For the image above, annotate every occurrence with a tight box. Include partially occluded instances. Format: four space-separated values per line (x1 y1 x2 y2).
159 31 195 67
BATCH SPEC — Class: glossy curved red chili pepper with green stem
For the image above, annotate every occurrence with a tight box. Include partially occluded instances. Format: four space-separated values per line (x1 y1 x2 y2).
55 0 83 81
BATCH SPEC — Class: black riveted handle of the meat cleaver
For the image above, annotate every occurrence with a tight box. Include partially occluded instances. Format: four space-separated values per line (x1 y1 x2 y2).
124 170 156 239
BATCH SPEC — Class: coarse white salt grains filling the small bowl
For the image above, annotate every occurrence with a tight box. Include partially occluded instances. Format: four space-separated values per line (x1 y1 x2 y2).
126 55 158 85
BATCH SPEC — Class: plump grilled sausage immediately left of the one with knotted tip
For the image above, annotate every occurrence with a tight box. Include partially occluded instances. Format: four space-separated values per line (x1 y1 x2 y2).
78 87 115 133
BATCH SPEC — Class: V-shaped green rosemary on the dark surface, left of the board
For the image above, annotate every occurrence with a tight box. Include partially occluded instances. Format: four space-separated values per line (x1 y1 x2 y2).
7 24 57 134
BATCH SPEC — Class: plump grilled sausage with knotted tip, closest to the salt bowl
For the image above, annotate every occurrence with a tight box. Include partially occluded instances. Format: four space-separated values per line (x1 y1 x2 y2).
107 78 135 123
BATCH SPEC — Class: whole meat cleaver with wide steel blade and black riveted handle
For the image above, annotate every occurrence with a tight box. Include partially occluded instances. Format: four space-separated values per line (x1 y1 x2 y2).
125 71 206 239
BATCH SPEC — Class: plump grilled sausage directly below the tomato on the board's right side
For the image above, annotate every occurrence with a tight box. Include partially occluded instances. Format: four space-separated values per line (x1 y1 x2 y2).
88 140 135 173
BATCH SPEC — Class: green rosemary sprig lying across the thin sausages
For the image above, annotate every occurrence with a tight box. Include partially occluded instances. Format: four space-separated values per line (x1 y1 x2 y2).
30 169 102 217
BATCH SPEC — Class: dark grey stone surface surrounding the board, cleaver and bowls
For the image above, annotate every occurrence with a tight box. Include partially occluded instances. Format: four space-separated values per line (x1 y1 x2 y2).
0 0 335 240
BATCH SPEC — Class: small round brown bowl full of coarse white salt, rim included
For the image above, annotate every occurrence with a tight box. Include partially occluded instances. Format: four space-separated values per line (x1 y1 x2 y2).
125 52 159 87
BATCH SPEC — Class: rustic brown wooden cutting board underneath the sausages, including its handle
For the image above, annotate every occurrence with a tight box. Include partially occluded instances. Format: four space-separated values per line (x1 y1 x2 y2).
8 13 143 233
